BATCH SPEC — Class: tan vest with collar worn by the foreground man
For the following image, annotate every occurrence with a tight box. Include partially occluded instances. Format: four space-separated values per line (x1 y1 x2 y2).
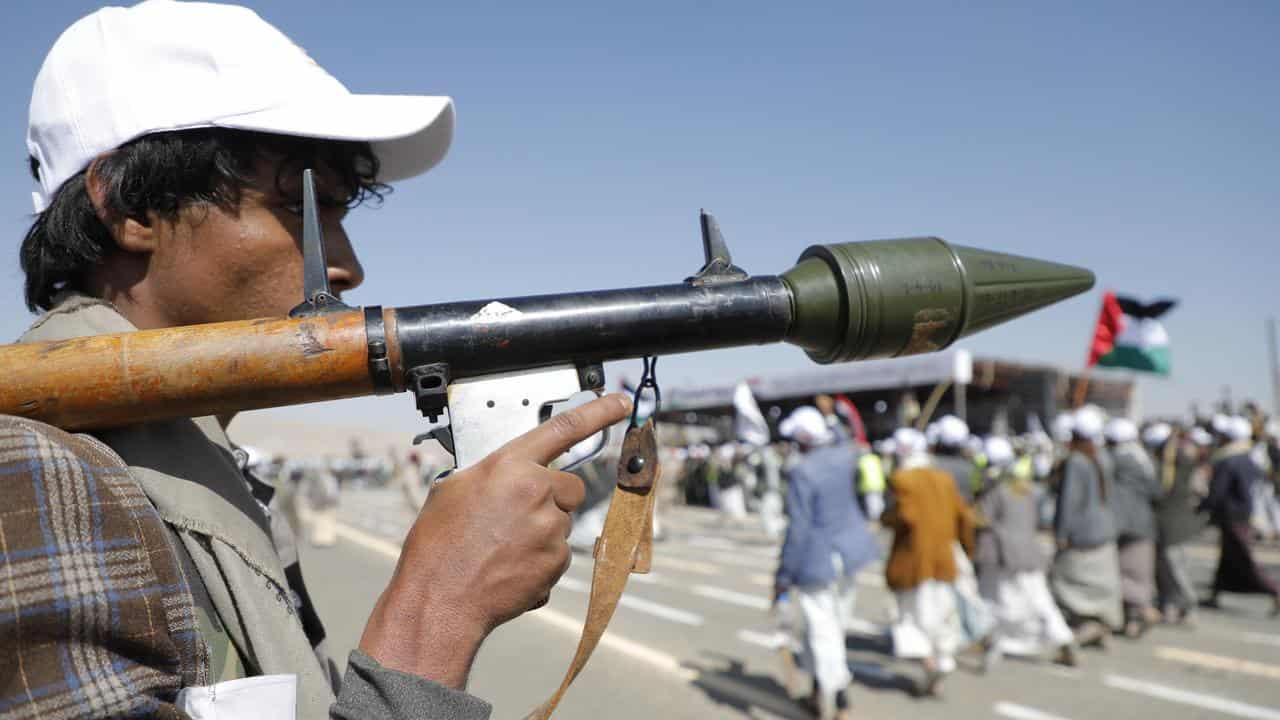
19 295 334 719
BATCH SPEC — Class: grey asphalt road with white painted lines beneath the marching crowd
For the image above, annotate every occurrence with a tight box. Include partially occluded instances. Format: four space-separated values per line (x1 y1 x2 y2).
303 491 1280 720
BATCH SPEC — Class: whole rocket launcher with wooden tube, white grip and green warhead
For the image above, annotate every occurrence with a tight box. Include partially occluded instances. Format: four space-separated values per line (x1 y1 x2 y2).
0 172 1093 468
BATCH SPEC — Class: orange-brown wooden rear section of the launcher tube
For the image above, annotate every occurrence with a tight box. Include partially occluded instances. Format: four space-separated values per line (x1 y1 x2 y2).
0 310 374 430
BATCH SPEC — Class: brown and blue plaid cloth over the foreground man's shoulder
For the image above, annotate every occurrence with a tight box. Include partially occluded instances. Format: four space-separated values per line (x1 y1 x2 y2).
0 416 210 720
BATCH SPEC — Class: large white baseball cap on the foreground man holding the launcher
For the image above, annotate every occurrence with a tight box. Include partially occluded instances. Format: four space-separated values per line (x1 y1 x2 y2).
27 0 453 210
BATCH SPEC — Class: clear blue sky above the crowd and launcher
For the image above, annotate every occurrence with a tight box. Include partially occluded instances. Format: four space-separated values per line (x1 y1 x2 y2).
0 0 1280 424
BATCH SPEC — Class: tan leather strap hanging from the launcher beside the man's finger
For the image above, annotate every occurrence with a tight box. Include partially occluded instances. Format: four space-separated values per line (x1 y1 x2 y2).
526 420 659 720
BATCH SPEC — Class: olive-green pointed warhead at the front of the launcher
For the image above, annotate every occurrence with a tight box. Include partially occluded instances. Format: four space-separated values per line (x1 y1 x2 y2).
782 237 1093 363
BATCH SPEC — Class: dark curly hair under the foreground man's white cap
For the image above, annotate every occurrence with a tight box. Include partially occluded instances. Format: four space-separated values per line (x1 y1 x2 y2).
20 128 390 313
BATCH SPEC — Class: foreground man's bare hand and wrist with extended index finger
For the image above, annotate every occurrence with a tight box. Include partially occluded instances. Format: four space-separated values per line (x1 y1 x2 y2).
360 395 631 687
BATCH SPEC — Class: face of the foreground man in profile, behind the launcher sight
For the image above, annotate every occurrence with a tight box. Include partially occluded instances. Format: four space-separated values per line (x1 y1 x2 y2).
146 160 365 325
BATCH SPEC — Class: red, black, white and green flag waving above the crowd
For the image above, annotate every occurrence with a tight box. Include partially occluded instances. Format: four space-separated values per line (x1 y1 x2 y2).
1089 291 1178 375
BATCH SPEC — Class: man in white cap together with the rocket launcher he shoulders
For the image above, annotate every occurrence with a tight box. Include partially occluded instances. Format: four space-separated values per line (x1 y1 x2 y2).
0 0 1093 717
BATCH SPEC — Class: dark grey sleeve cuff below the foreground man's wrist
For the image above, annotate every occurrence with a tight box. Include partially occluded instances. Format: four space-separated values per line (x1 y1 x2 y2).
329 650 493 720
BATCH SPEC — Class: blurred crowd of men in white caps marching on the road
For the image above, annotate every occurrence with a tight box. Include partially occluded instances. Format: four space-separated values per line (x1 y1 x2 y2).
668 406 1280 717
